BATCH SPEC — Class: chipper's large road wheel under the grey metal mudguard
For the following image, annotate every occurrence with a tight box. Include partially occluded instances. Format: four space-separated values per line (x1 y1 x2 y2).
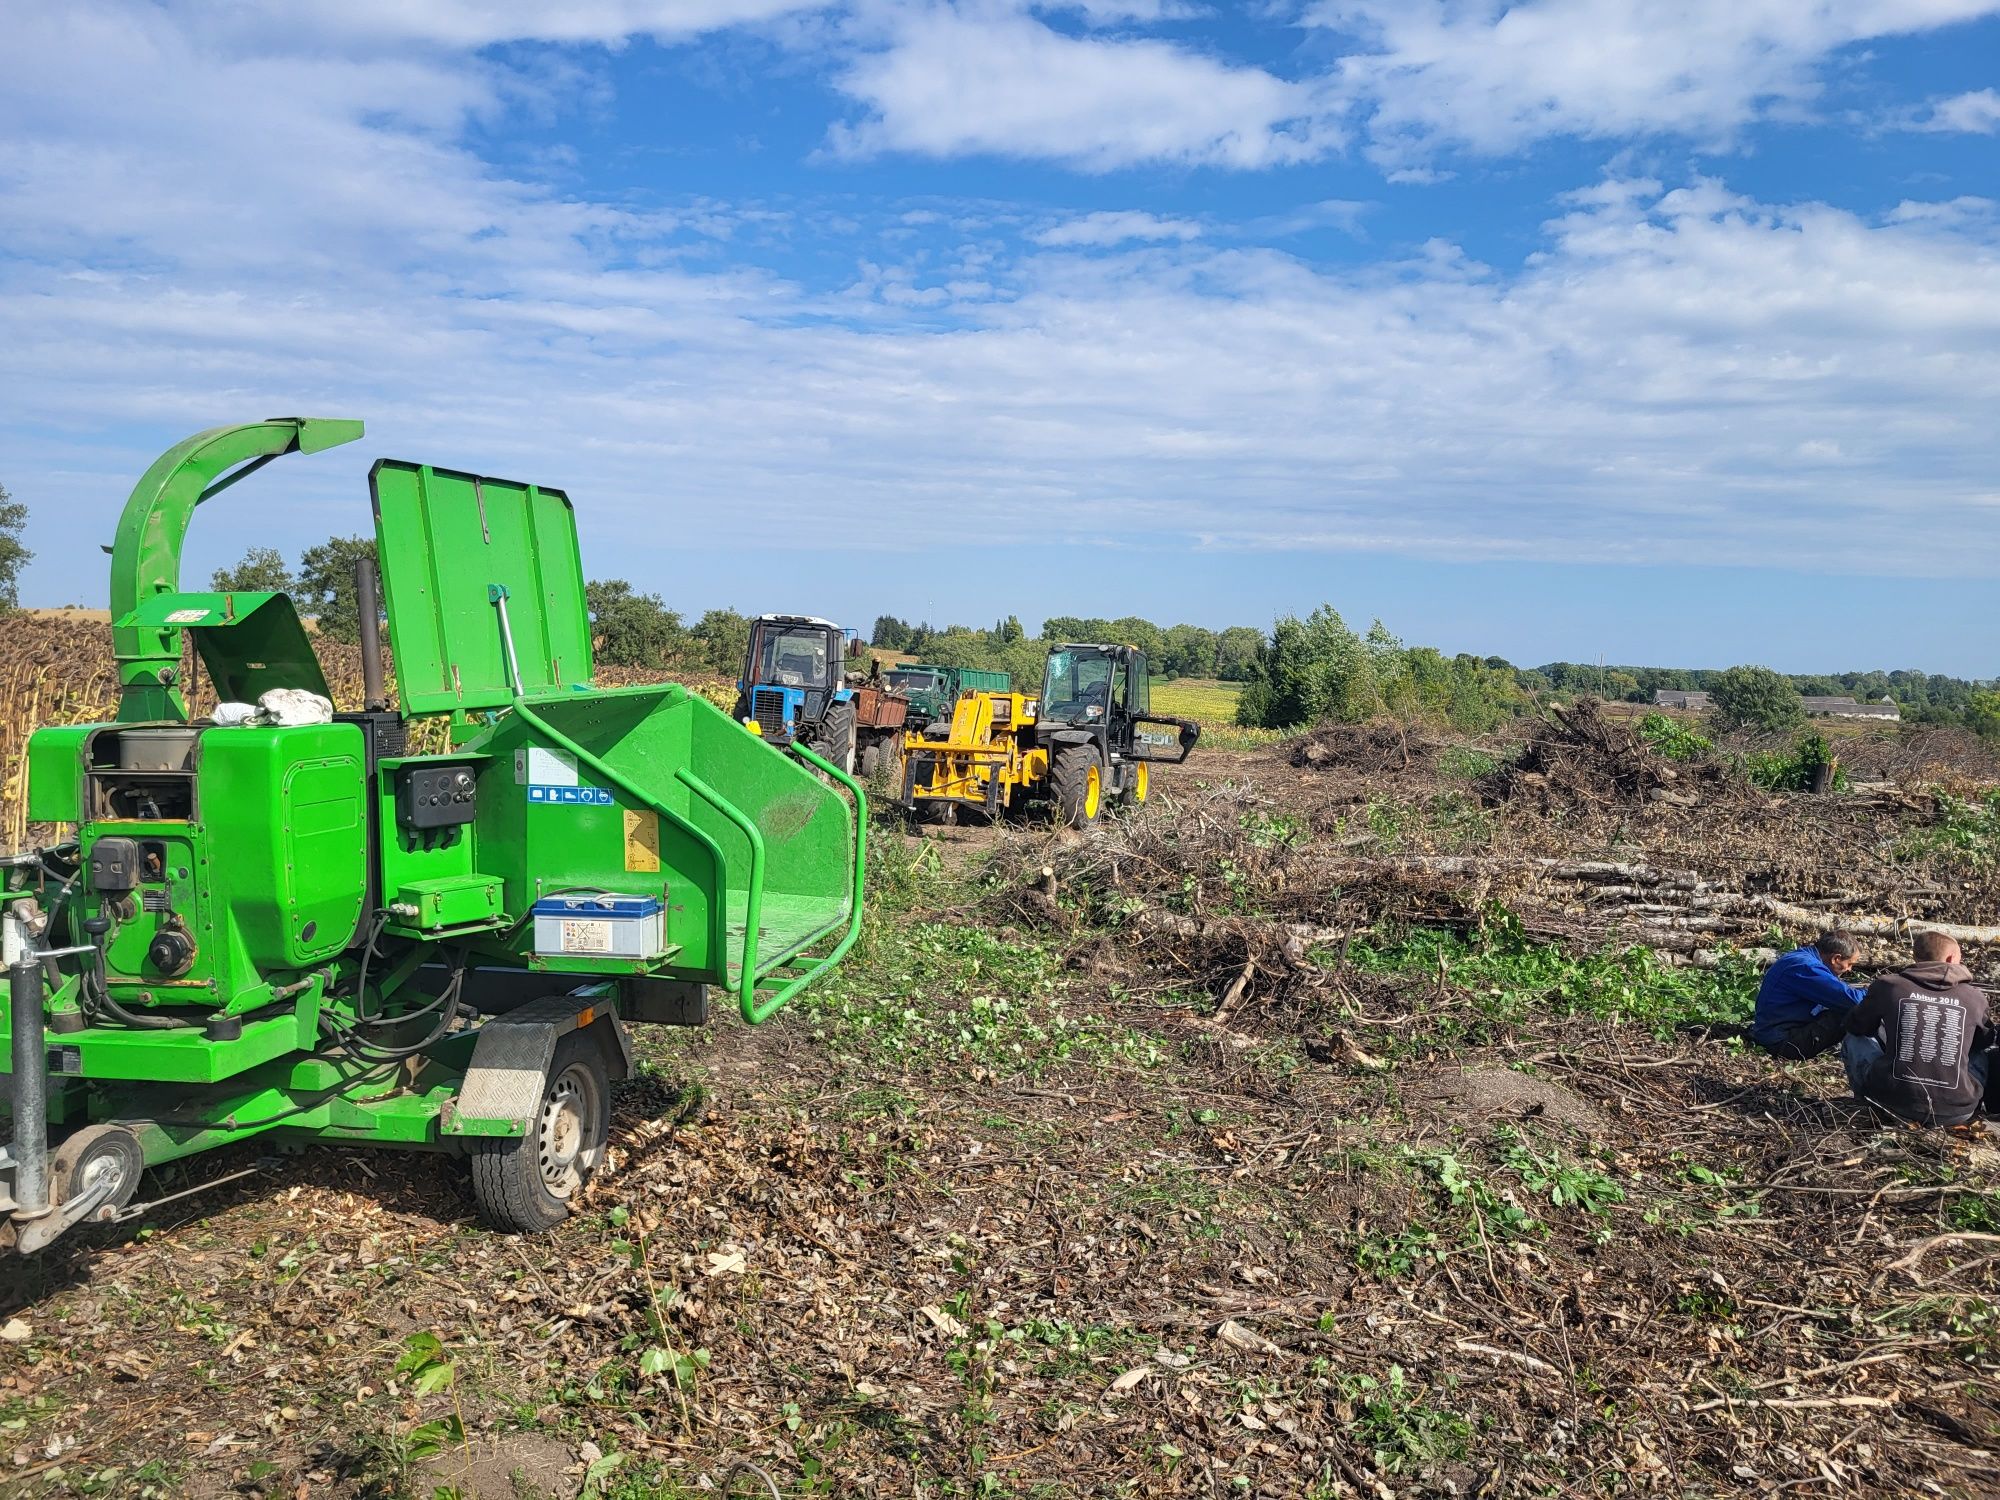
472 1032 612 1234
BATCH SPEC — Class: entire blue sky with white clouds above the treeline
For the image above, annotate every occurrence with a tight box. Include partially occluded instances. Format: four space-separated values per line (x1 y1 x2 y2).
0 0 2000 676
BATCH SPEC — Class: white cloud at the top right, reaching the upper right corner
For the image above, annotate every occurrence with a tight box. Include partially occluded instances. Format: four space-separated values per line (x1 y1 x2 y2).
1306 0 2000 162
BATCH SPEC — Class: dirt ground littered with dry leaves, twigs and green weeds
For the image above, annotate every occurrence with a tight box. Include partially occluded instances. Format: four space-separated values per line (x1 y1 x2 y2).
0 738 2000 1496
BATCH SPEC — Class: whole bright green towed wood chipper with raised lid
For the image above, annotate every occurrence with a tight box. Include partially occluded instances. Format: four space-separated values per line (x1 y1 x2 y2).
0 418 866 1254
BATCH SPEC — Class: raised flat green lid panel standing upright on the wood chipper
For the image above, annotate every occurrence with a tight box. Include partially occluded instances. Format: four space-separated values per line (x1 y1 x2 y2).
368 458 590 714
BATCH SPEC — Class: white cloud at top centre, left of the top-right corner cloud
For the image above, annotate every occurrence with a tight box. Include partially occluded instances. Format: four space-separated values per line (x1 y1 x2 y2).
832 0 1340 172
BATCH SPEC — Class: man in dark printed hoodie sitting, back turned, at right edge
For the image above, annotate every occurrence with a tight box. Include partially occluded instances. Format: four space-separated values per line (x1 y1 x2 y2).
1842 932 1994 1126
